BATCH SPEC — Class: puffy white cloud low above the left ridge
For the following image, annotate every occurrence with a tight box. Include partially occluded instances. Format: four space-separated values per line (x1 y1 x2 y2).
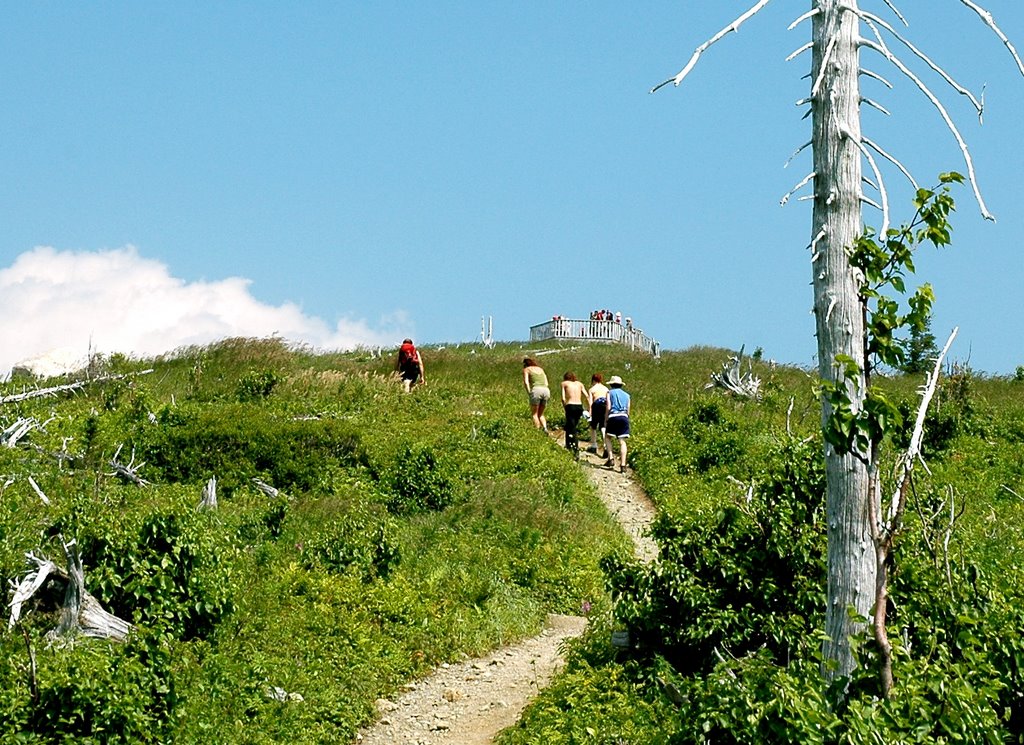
0 247 409 378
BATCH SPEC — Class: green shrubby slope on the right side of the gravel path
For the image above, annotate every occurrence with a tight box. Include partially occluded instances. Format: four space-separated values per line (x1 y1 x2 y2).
501 350 1024 745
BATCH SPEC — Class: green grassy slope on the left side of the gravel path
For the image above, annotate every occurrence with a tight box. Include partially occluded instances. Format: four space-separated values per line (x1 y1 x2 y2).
0 340 629 743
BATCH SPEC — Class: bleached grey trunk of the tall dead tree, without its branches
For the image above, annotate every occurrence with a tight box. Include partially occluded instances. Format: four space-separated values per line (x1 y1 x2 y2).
811 0 877 680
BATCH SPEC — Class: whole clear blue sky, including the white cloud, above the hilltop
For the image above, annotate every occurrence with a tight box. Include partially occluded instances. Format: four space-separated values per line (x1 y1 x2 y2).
0 0 1024 375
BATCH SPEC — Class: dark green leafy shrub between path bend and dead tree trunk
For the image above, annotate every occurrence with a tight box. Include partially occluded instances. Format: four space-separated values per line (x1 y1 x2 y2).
604 440 825 674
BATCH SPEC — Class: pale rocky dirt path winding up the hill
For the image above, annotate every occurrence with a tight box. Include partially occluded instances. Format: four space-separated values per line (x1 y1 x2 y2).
356 435 657 745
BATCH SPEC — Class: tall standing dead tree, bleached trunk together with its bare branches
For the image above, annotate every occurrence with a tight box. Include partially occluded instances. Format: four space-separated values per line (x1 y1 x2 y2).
651 0 1024 691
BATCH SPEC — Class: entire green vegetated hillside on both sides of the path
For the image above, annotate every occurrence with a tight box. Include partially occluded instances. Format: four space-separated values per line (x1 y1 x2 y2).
0 340 1024 743
